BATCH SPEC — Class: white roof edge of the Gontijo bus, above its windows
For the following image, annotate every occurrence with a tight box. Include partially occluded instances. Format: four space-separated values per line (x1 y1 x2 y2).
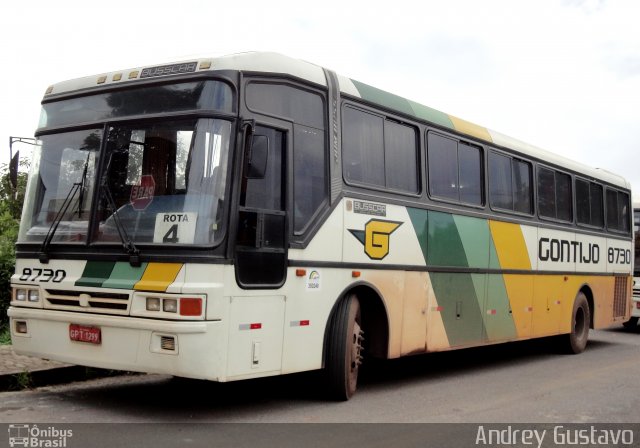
45 52 631 189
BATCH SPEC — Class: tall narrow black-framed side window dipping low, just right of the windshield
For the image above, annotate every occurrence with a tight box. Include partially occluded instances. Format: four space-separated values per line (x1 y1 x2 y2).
235 126 288 288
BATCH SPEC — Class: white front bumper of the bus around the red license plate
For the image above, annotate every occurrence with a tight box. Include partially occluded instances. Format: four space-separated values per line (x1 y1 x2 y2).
7 307 227 381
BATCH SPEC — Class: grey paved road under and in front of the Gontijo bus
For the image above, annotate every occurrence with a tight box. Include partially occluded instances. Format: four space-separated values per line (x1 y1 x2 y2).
0 328 640 424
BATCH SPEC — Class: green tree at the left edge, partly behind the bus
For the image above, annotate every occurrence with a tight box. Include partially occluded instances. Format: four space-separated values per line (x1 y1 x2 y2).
0 160 28 327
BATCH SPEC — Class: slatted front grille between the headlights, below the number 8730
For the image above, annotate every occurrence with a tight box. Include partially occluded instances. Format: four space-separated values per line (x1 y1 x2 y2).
45 289 129 314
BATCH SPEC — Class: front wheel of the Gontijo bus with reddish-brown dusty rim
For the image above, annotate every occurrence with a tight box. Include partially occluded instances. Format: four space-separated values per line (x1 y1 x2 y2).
325 294 364 401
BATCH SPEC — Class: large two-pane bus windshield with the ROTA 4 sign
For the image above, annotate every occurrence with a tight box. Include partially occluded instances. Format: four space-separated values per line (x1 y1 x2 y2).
20 119 231 245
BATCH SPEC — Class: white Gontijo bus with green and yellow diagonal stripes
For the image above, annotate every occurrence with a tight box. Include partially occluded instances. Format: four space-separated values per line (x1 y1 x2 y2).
8 53 633 400
